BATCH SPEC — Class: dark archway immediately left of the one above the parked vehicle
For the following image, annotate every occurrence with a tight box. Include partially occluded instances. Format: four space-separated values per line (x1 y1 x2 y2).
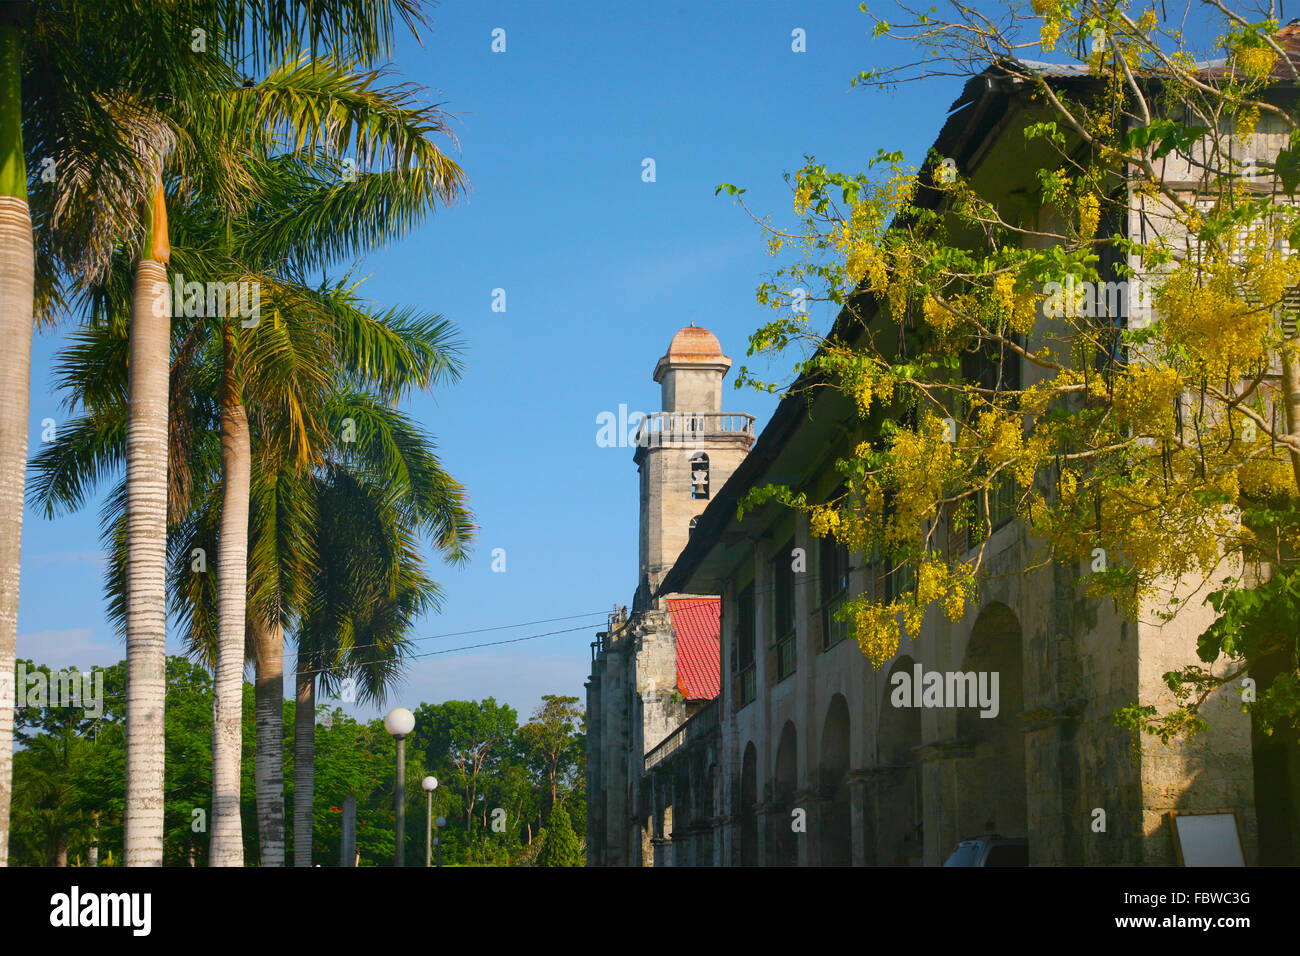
867 657 926 866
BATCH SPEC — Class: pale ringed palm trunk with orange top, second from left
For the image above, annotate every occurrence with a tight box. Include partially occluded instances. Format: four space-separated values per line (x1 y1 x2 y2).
125 179 172 866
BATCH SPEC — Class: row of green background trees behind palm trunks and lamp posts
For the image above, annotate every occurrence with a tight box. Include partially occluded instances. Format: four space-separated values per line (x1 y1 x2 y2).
10 657 586 866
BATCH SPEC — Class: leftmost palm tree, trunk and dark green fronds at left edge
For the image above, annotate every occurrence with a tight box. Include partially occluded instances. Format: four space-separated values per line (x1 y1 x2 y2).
0 0 213 866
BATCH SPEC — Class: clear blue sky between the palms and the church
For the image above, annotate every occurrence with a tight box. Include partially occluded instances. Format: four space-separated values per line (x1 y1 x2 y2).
18 0 1232 717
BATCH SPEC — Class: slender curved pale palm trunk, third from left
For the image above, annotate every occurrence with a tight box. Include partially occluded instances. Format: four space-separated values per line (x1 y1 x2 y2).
208 323 252 866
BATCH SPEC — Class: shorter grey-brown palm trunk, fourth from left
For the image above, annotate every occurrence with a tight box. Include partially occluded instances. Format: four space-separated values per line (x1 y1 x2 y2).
252 620 285 866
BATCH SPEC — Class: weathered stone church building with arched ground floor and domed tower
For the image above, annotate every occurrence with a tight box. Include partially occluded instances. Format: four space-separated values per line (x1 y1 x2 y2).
588 57 1300 866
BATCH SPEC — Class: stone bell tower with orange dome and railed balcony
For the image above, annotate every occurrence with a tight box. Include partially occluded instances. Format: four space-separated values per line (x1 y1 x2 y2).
633 324 754 609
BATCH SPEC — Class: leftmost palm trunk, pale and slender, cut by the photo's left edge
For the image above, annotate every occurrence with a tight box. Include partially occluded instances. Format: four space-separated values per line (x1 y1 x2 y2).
0 26 35 866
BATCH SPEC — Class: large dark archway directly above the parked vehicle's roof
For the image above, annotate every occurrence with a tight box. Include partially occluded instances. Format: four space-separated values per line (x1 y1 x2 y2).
953 604 1028 853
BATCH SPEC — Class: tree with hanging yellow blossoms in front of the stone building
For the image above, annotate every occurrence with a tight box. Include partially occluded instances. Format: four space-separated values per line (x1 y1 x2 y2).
719 0 1300 739
